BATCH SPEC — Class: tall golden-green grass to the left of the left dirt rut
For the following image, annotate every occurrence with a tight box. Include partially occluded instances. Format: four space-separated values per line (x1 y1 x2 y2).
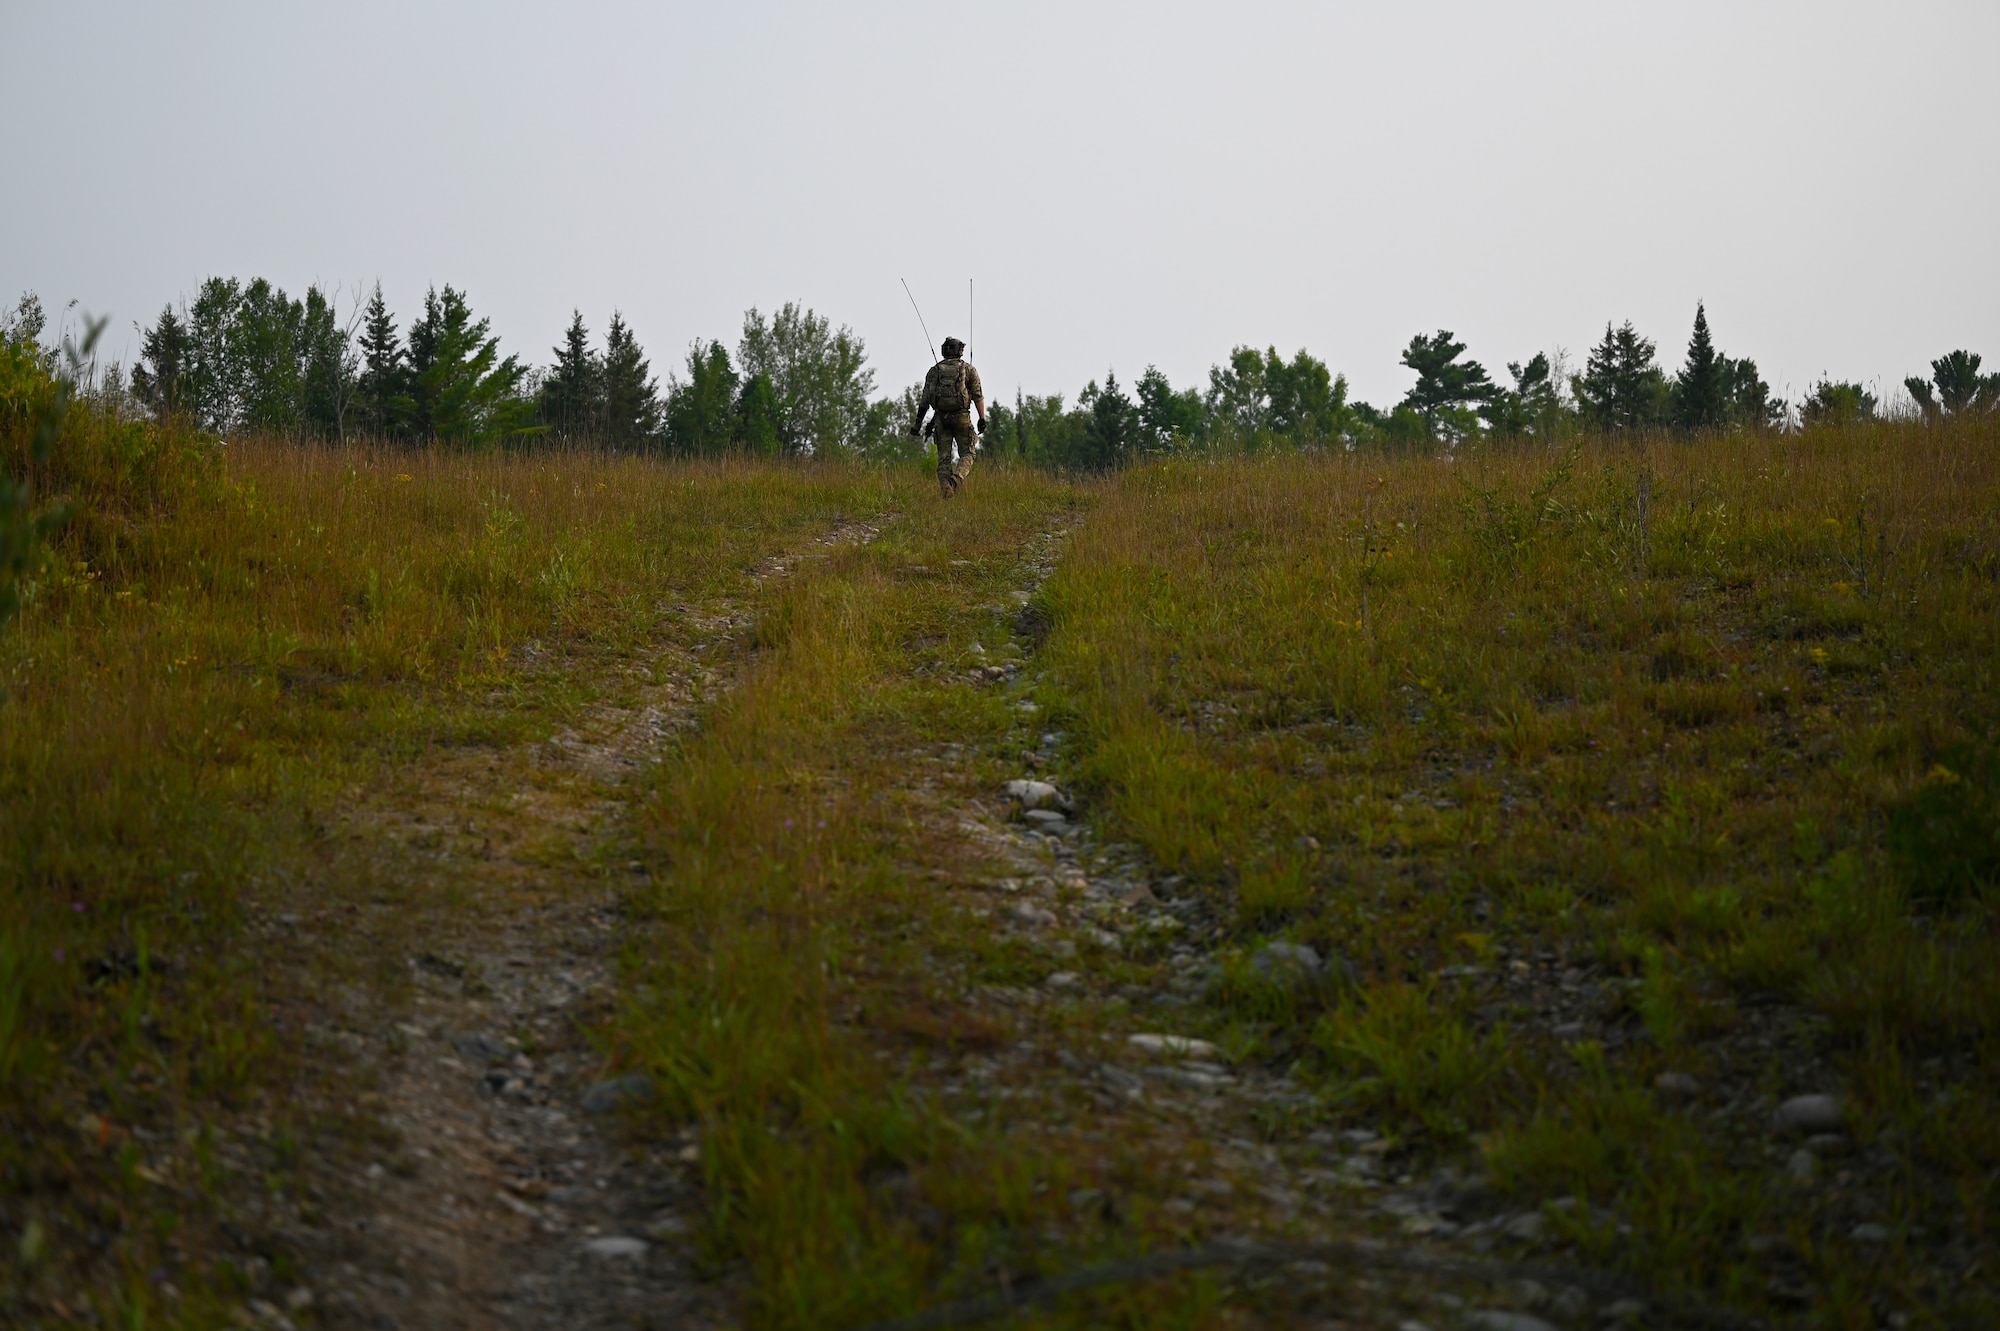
0 385 886 1315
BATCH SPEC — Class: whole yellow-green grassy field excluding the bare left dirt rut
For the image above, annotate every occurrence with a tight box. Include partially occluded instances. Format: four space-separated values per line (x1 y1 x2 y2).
0 399 2000 1327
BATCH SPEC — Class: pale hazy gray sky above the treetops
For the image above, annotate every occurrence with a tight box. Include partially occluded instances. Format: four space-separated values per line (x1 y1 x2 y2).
0 0 2000 404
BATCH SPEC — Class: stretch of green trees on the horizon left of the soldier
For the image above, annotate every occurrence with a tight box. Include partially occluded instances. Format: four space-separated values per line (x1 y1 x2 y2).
130 278 898 456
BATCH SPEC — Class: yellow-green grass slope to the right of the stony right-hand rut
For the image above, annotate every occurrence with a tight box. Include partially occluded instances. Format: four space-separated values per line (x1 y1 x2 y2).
1044 426 2000 1325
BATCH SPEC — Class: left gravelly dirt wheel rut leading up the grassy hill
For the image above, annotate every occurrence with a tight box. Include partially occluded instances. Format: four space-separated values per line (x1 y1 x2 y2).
262 524 876 1331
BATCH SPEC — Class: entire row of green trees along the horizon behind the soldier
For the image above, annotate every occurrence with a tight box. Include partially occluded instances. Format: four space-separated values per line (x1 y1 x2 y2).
54 278 2000 470
